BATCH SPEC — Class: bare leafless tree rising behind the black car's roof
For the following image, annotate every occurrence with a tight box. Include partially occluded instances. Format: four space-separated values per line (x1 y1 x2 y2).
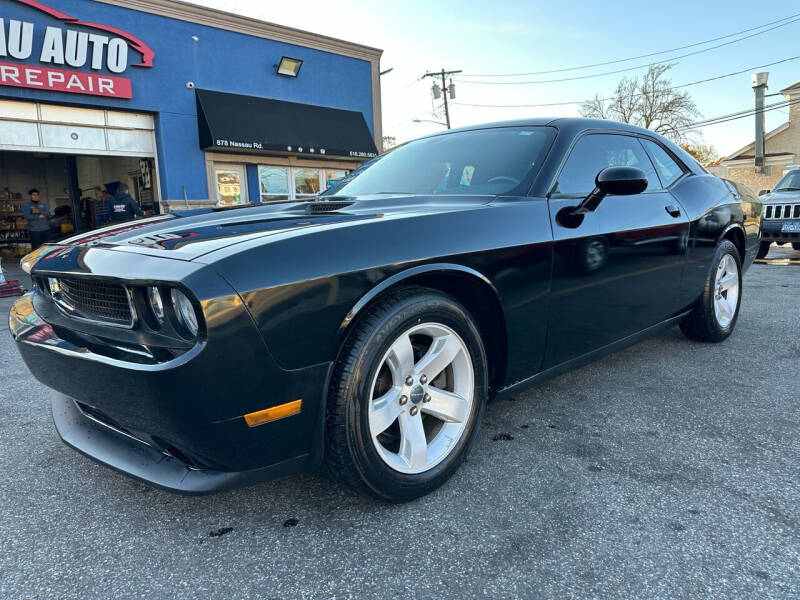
580 64 700 141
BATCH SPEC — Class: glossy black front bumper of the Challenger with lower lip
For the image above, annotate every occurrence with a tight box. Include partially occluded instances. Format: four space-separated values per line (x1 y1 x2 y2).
9 292 329 493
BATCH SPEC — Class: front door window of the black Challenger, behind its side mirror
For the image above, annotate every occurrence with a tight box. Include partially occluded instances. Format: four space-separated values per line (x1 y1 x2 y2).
553 133 661 195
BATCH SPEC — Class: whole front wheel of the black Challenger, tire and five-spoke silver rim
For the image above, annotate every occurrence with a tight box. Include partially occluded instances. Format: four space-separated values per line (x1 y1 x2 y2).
324 287 487 502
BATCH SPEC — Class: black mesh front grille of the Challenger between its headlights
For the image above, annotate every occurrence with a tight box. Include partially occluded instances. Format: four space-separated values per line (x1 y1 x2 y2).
50 277 134 327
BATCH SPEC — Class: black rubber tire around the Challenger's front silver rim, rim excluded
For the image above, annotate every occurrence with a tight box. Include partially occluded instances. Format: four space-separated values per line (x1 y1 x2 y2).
323 287 488 502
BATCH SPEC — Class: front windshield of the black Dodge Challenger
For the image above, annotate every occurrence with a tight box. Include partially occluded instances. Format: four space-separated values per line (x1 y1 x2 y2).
324 127 554 196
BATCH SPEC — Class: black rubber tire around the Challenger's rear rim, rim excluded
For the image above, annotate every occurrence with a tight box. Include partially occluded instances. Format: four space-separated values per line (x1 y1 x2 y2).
680 240 742 342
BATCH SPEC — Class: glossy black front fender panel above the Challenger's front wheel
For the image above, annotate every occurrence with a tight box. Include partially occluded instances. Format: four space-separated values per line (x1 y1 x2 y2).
209 198 552 373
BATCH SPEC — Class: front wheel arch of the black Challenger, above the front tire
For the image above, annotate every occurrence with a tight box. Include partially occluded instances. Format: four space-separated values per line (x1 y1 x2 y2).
336 263 508 391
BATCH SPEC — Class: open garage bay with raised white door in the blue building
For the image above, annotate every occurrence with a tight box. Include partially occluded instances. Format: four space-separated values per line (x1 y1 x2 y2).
0 100 159 255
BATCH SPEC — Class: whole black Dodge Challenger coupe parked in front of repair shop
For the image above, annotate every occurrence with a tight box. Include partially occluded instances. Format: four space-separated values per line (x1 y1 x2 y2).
10 119 761 502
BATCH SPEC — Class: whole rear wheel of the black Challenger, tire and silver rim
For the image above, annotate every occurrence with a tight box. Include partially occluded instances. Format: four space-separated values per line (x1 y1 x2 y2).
680 240 742 342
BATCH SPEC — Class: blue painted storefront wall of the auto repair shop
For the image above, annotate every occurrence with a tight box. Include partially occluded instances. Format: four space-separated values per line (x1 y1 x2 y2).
0 0 373 200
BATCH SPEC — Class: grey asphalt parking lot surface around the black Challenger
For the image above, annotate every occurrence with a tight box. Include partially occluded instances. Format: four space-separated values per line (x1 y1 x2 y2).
0 250 800 599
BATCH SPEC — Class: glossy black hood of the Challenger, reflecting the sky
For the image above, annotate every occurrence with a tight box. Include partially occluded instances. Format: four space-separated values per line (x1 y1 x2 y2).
32 195 491 260
